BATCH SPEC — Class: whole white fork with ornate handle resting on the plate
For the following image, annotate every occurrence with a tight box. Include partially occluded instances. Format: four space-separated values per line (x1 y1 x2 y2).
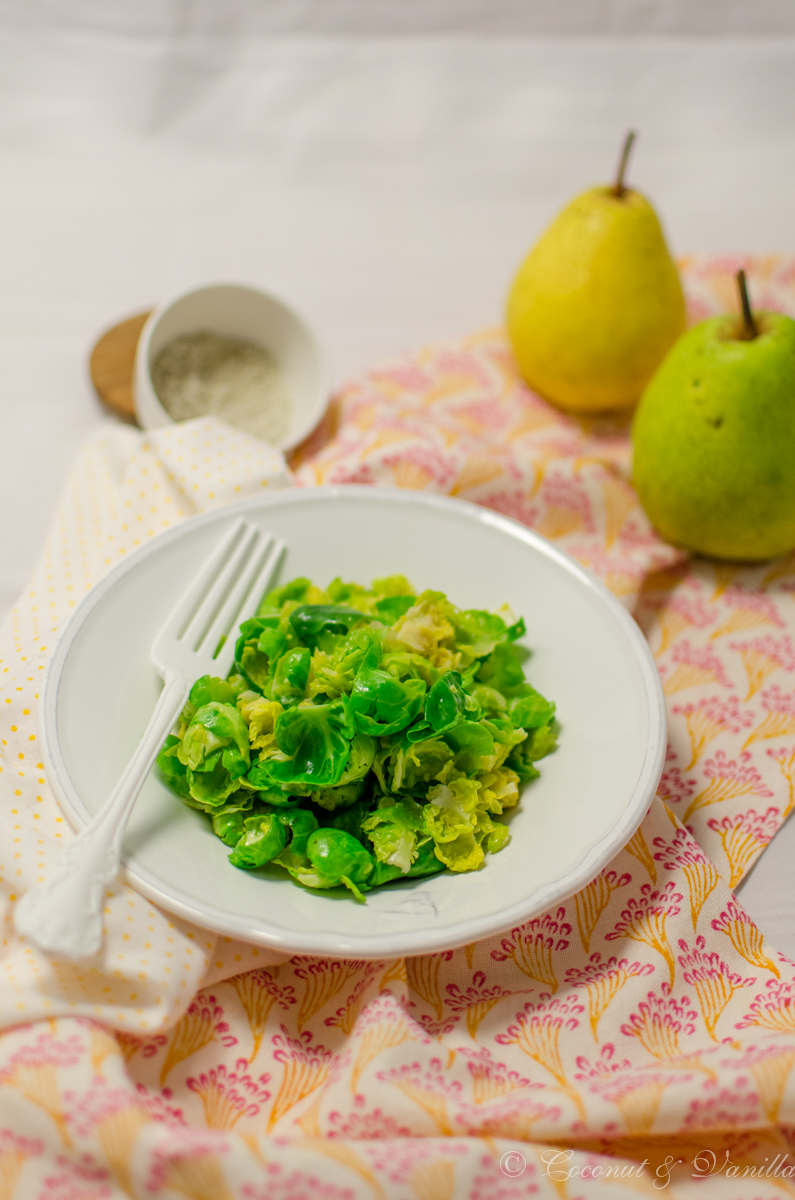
14 518 285 961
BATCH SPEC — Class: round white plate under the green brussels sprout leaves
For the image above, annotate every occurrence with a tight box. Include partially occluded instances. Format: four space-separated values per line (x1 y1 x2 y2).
42 487 665 959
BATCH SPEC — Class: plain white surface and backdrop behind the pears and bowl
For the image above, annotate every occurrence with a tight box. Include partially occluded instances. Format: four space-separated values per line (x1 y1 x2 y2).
0 0 795 953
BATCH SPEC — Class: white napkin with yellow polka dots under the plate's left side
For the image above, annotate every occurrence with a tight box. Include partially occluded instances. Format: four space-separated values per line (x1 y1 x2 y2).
0 418 291 1031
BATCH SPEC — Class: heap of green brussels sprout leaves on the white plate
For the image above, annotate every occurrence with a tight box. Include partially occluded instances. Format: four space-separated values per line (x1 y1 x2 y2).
152 575 556 900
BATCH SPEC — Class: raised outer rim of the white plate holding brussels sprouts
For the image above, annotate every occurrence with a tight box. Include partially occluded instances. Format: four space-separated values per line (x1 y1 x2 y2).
38 484 667 960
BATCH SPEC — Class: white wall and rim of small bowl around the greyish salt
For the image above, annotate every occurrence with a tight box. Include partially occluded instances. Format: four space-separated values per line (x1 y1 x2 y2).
133 283 329 451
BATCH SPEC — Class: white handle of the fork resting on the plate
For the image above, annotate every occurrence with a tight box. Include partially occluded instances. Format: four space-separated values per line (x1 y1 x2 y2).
14 672 190 960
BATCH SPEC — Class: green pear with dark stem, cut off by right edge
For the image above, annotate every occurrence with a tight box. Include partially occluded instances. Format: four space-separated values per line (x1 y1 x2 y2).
633 272 795 562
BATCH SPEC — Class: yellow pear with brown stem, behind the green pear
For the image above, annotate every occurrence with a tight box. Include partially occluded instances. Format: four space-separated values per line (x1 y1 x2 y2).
507 133 685 413
